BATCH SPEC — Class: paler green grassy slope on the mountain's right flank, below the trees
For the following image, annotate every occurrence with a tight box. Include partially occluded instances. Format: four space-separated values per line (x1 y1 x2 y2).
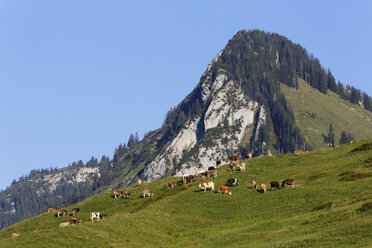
281 79 372 150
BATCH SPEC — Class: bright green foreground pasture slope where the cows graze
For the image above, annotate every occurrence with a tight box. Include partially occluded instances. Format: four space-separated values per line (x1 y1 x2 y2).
0 140 372 248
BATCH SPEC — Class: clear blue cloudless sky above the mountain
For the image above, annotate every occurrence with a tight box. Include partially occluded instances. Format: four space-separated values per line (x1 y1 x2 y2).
0 0 372 189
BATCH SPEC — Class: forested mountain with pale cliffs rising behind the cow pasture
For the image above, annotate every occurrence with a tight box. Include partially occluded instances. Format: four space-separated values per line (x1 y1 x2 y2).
0 30 372 231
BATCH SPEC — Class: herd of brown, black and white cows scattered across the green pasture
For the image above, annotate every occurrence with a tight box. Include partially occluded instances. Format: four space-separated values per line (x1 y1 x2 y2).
12 153 298 238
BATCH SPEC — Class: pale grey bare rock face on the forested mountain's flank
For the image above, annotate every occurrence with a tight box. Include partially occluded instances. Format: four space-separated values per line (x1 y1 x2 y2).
142 54 266 181
